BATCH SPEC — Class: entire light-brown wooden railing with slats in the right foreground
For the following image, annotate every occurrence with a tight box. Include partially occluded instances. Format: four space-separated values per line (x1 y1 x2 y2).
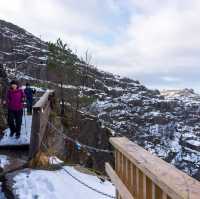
106 138 200 199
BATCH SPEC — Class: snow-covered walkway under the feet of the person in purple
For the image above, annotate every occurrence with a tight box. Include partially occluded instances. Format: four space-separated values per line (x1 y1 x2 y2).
0 109 32 146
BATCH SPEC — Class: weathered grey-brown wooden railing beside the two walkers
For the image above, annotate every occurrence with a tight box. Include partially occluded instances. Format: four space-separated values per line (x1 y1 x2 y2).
29 91 54 159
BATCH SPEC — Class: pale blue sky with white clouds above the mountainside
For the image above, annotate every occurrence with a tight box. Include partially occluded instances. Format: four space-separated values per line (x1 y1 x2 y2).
0 0 200 92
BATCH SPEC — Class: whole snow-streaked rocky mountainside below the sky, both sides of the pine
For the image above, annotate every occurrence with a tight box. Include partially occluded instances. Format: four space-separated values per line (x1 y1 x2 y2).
0 21 200 180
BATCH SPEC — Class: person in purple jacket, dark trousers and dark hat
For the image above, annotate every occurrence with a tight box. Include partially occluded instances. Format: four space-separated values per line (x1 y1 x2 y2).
7 80 25 139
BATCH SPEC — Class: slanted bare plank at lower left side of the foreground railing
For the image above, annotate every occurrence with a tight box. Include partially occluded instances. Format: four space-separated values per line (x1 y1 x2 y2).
106 163 134 199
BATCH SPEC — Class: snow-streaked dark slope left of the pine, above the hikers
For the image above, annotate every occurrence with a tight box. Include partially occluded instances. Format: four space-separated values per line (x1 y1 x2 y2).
0 20 48 79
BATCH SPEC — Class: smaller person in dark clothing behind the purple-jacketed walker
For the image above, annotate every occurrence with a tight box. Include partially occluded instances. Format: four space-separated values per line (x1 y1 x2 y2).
24 83 36 115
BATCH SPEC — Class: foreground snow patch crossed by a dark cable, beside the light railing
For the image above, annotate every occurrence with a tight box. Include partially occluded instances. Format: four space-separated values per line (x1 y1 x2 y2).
13 166 115 199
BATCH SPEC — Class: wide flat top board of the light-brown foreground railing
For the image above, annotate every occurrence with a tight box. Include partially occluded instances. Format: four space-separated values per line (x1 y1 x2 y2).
110 138 200 199
